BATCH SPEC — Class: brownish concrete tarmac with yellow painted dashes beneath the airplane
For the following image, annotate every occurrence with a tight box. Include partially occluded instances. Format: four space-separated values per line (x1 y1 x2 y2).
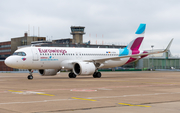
0 71 180 113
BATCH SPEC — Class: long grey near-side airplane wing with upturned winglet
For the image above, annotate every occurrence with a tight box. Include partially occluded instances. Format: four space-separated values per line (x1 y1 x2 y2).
84 39 173 63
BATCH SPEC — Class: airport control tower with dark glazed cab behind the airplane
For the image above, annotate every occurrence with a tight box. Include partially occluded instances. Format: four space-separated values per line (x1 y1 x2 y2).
71 26 85 44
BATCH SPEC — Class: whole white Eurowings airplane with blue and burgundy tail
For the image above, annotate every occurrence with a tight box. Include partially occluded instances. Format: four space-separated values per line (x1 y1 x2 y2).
5 23 173 80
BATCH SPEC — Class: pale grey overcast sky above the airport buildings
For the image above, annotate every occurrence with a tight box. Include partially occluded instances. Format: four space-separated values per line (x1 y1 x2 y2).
0 0 180 56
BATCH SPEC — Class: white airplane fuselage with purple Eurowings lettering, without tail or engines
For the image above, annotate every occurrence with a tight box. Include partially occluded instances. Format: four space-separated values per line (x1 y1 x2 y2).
5 47 129 69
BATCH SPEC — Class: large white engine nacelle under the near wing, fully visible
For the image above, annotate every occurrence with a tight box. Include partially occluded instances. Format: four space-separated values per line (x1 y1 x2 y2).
73 62 96 75
